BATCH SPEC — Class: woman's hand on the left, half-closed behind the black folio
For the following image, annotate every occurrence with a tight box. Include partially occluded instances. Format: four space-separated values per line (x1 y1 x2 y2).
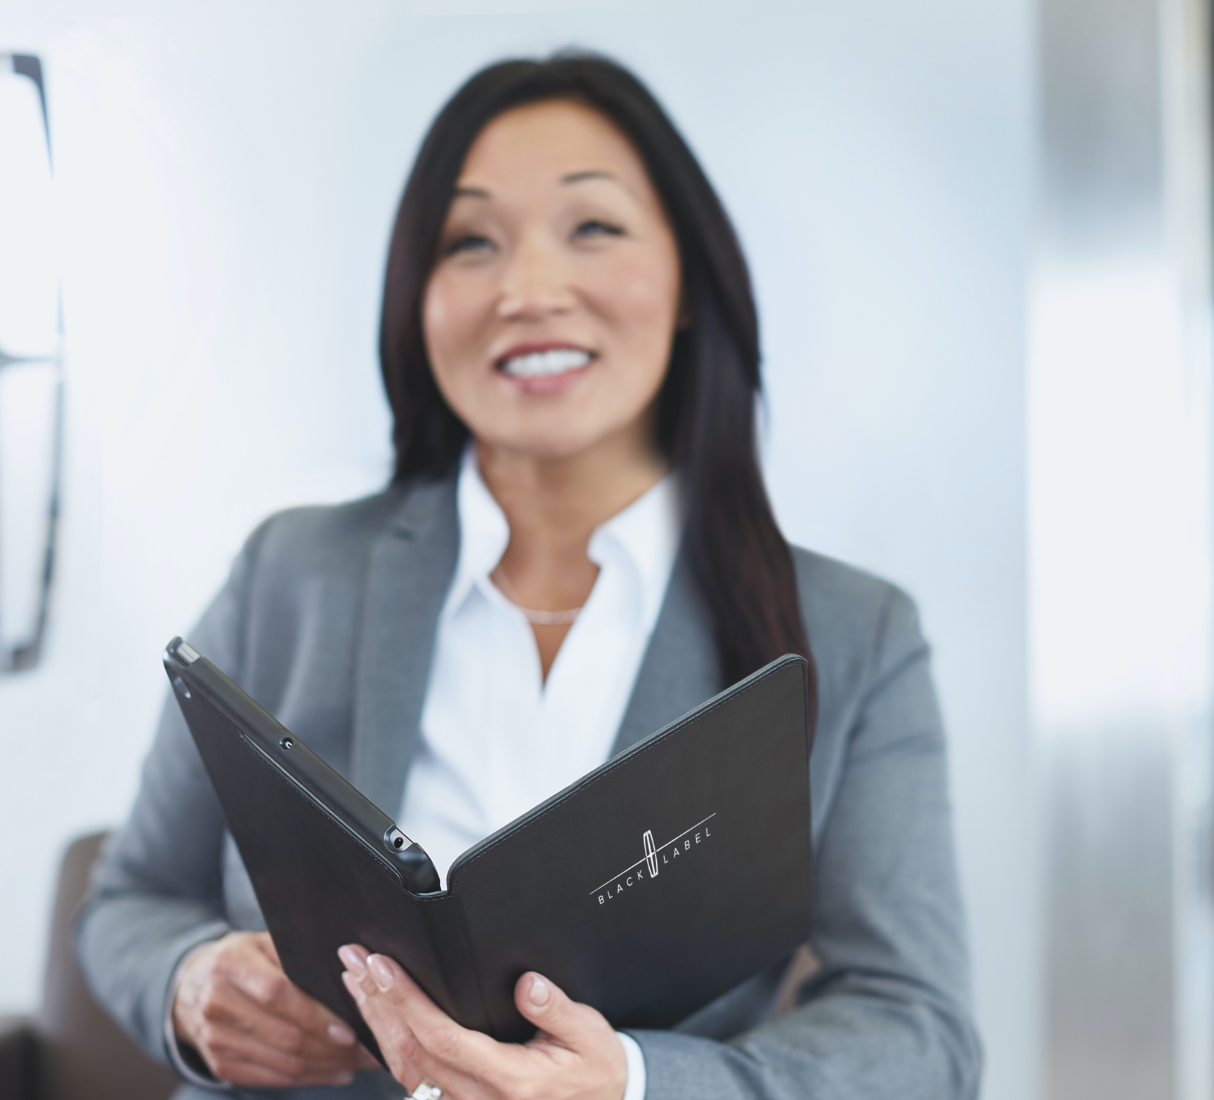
172 932 376 1088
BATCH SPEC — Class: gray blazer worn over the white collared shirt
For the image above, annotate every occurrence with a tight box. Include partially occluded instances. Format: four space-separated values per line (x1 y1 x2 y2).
79 480 981 1100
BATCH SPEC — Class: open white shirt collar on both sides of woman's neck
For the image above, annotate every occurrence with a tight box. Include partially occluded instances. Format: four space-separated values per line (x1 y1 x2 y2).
443 444 681 626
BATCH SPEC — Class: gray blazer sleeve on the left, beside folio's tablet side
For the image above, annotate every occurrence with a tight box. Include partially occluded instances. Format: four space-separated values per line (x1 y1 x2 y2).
76 526 265 1061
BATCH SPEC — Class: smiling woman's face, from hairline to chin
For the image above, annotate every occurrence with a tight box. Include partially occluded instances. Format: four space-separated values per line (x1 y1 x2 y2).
422 100 681 459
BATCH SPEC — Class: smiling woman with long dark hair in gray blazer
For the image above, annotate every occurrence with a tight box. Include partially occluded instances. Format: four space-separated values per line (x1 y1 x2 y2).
80 55 978 1100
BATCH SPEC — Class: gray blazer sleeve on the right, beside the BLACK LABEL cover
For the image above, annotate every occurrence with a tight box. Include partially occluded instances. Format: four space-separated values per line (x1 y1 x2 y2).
631 588 981 1100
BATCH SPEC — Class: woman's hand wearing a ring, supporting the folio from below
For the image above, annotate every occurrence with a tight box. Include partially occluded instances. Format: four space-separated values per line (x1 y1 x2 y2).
337 945 628 1100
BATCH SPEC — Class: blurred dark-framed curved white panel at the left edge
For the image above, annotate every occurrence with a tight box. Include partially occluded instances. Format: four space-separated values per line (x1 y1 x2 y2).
0 53 63 674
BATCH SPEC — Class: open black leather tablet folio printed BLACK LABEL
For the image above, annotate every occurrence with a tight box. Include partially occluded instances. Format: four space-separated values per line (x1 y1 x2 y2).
156 639 811 1055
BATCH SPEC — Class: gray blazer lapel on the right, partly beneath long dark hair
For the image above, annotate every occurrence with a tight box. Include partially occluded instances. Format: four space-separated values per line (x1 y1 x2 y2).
612 550 724 755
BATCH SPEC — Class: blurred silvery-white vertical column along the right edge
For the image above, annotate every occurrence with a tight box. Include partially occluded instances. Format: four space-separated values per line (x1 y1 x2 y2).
1028 0 1214 1100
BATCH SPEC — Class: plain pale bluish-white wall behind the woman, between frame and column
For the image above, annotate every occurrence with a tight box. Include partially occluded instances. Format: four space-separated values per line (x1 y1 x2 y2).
0 0 1039 1100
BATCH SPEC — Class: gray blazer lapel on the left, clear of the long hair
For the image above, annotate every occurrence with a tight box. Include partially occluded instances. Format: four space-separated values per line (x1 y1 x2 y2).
351 475 459 818
